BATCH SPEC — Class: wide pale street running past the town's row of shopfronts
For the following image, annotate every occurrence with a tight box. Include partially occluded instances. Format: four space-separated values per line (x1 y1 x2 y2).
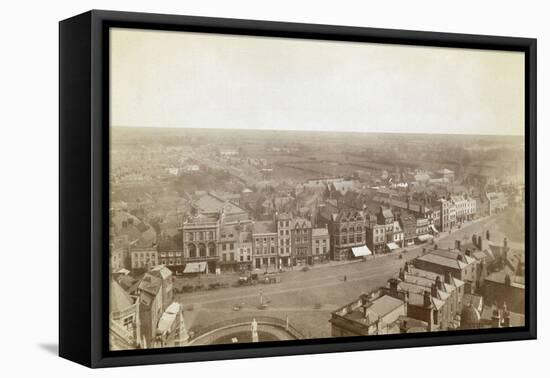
176 213 524 337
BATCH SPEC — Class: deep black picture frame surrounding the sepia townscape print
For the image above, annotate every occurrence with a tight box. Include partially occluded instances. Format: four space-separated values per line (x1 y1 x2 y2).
59 10 537 367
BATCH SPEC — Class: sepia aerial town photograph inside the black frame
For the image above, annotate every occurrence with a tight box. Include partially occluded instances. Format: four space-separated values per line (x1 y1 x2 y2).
109 29 527 350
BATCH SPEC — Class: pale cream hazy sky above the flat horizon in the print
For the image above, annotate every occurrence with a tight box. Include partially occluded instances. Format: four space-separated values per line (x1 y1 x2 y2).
111 29 524 135
